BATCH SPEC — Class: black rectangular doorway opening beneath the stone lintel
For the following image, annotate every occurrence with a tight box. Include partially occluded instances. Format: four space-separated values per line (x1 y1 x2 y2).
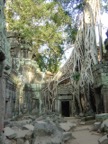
61 101 70 117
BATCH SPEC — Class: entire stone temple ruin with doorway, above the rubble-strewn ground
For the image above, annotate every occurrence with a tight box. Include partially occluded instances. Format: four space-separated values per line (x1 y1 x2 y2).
0 2 108 124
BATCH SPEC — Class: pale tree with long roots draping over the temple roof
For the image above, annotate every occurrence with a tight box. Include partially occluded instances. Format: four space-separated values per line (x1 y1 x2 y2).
44 0 104 112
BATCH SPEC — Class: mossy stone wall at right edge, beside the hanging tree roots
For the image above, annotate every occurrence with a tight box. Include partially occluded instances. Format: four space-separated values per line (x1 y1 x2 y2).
93 61 108 113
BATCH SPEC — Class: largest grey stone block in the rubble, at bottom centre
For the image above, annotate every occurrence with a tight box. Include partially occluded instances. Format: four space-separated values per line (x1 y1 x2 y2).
33 121 63 144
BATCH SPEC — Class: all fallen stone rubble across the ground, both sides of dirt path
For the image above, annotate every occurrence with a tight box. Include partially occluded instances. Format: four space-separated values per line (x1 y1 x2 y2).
4 113 108 144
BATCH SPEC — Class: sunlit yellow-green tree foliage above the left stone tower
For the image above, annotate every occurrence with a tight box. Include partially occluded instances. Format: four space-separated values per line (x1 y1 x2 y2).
6 0 71 72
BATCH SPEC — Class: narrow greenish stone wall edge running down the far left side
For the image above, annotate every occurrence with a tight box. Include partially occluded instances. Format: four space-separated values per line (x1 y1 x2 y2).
0 0 11 144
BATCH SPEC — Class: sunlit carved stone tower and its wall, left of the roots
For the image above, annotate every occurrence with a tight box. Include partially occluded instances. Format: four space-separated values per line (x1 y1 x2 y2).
6 32 44 116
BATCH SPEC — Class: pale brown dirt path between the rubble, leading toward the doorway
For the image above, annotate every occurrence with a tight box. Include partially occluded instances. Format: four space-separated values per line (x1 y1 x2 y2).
66 118 102 144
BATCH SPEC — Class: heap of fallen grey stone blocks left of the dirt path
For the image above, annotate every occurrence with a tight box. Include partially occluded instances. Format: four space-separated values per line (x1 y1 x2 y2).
4 113 76 144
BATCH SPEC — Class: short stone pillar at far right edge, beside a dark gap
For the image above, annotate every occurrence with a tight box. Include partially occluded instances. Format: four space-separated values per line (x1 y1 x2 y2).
101 86 108 113
